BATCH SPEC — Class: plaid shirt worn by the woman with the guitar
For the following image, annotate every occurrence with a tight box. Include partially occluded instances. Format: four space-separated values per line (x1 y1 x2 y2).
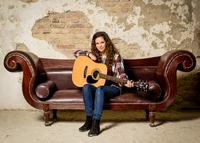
74 50 128 87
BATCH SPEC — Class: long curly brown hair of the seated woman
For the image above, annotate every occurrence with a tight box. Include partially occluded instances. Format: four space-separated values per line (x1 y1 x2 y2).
91 31 119 65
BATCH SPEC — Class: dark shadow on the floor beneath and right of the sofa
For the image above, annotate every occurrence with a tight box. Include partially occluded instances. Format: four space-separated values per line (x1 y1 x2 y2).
38 109 200 128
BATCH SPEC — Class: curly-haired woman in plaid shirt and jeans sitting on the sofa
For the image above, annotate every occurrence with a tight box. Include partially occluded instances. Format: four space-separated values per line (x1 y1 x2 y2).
74 31 134 137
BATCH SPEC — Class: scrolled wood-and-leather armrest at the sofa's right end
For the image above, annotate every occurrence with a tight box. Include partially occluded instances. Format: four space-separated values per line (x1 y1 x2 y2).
156 50 196 107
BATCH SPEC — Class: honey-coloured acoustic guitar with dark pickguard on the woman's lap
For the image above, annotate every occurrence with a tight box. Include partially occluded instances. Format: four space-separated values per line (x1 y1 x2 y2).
72 56 149 92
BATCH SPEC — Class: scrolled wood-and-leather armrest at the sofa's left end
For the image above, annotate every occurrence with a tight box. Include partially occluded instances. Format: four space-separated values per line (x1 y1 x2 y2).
4 50 46 109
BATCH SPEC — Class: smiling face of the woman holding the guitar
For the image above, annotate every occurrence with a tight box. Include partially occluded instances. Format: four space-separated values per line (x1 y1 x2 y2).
95 37 106 54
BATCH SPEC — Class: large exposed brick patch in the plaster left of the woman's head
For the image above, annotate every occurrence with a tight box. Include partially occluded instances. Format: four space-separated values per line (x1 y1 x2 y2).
32 11 93 56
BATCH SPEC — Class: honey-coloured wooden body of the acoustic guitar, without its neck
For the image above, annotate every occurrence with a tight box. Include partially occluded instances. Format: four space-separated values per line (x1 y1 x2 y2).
72 56 107 87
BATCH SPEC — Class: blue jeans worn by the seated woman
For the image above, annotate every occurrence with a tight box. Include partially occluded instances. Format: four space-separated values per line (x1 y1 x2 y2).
82 84 120 120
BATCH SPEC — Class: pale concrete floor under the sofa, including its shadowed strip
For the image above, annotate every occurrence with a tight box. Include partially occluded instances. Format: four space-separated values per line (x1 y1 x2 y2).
0 110 200 143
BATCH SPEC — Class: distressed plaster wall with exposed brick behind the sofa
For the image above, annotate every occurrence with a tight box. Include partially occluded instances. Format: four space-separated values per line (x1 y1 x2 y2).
0 0 200 109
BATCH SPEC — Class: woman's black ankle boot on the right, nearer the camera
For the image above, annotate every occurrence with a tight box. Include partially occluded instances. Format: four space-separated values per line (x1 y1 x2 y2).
88 120 100 137
